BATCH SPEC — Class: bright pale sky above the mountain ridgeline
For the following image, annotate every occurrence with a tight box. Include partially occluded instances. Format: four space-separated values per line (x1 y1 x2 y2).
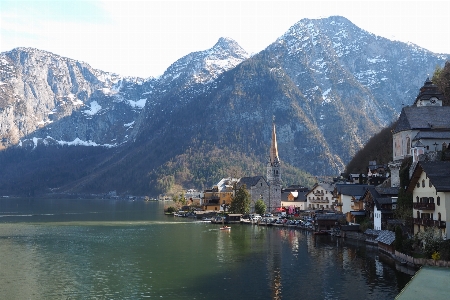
0 0 450 78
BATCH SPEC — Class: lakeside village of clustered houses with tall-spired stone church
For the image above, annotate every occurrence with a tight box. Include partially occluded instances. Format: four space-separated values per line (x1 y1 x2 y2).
175 78 450 260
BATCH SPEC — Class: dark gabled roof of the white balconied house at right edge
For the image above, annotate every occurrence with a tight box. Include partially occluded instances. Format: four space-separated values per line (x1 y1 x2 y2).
408 161 450 192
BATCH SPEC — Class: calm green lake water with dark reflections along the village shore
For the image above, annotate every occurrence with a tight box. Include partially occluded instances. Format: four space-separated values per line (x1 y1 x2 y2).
0 198 411 300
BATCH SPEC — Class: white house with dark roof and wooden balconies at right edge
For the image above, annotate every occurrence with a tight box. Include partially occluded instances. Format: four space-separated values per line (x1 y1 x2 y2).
408 161 450 239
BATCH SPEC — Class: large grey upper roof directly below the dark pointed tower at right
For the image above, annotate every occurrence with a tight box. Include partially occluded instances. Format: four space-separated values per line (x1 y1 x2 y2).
393 106 450 133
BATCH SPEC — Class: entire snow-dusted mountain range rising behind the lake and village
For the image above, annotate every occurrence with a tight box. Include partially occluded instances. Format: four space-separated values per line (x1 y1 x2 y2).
0 17 449 194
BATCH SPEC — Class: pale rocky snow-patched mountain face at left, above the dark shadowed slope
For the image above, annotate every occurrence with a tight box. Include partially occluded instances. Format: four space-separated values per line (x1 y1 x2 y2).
0 38 248 148
